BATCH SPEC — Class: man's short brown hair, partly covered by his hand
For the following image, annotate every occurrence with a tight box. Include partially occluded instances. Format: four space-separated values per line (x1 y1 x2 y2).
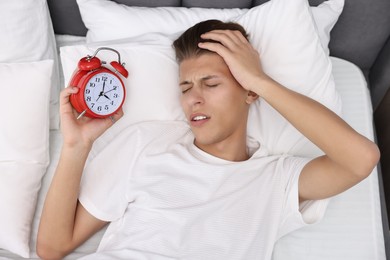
173 20 248 63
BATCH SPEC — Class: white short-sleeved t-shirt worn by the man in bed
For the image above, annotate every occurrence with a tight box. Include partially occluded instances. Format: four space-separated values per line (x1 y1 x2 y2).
79 122 327 260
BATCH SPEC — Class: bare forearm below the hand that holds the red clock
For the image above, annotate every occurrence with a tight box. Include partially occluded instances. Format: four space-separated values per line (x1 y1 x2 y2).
38 146 90 256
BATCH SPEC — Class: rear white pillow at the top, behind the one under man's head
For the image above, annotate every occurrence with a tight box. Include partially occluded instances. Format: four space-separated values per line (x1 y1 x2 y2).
77 0 344 53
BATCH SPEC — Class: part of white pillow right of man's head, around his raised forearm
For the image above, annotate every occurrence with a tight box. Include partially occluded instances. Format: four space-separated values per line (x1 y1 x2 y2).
234 0 341 156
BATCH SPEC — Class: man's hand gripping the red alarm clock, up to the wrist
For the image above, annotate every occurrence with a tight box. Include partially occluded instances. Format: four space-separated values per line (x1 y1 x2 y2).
60 87 123 147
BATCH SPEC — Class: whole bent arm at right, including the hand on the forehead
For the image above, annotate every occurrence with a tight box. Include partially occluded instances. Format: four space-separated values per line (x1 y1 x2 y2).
199 30 379 201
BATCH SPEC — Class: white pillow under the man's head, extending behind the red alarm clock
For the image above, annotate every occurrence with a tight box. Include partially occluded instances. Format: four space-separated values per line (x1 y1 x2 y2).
61 0 341 156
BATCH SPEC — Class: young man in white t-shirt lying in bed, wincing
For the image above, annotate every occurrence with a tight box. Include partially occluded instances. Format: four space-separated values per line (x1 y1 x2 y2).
37 20 379 260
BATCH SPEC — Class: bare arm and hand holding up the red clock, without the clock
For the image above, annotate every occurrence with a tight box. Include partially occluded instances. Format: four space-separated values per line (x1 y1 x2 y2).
37 87 122 259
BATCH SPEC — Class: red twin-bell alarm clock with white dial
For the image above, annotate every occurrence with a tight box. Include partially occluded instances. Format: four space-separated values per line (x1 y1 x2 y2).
69 47 129 118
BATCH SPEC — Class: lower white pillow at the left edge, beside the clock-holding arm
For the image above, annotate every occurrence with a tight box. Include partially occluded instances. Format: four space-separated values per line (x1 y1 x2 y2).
0 60 53 257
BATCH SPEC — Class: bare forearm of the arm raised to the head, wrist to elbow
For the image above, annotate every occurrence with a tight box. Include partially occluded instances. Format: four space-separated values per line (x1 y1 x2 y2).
254 77 375 174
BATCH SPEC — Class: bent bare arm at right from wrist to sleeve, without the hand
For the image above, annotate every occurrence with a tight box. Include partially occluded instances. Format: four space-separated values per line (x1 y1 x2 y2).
255 80 379 200
